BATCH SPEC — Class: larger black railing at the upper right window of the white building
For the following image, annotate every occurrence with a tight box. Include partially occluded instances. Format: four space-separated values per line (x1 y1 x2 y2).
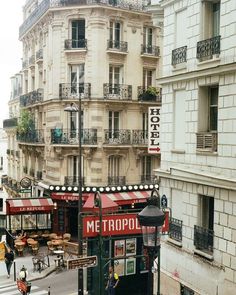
197 36 221 59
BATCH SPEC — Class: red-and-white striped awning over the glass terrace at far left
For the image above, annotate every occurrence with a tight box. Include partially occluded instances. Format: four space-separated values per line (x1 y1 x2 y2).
6 198 53 215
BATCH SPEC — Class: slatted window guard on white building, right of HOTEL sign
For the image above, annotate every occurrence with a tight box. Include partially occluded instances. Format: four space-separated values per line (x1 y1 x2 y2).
196 132 218 153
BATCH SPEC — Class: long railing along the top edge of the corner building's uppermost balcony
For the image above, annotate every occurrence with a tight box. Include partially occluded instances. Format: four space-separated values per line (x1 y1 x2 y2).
19 0 148 38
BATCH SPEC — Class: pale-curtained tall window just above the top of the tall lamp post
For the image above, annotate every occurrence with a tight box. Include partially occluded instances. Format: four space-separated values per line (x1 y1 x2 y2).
70 64 84 94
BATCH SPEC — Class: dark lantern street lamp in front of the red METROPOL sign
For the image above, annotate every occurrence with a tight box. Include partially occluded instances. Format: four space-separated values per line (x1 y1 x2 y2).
138 189 165 295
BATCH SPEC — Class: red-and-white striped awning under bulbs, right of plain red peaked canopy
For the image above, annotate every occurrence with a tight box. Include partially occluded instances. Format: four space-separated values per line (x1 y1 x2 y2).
105 191 151 205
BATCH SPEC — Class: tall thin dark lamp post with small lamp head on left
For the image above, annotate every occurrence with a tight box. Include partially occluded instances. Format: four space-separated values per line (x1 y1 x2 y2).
64 93 84 295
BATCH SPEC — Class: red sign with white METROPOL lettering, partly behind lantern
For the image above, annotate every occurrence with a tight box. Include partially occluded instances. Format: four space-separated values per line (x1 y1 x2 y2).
83 212 169 238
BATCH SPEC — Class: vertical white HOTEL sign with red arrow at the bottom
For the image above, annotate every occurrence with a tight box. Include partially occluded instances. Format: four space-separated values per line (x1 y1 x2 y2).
148 107 161 154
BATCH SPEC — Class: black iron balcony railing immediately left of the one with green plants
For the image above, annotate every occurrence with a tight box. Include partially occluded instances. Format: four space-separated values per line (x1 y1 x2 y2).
103 83 132 100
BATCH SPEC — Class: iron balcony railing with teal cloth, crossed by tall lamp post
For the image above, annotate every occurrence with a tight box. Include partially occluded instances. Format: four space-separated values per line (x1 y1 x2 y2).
51 128 97 145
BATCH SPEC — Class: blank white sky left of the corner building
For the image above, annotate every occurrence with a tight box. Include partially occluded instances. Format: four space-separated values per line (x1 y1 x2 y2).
0 0 25 128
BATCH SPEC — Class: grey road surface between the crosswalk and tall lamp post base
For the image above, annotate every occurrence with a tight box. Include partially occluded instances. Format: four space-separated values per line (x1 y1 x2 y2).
35 270 78 295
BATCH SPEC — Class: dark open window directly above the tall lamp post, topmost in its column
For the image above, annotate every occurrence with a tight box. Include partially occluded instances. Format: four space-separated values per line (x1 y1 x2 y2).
71 19 85 48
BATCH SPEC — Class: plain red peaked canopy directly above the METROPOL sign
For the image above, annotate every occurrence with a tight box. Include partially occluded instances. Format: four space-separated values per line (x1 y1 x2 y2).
83 194 119 212
